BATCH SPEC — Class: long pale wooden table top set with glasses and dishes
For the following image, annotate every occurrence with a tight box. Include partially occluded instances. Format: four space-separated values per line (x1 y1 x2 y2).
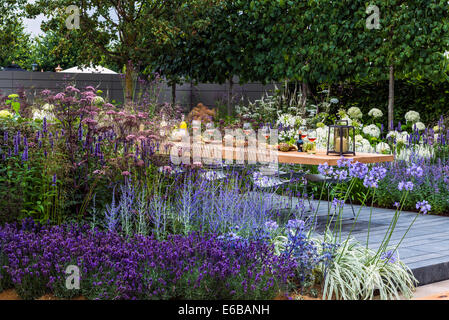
161 142 394 166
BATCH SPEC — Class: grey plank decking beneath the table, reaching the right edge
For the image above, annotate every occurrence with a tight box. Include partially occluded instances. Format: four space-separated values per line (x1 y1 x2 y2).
272 196 449 285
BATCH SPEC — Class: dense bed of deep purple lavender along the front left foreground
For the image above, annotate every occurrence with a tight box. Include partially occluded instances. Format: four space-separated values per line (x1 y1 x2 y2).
0 220 296 299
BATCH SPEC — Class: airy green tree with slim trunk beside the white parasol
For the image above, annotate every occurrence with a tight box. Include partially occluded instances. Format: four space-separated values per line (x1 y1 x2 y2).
26 0 218 98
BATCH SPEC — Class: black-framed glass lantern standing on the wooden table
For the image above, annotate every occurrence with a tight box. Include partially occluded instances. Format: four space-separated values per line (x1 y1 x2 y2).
327 120 355 156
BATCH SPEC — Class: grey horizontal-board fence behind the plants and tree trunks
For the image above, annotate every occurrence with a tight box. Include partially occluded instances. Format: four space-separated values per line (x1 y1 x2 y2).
0 71 275 110
